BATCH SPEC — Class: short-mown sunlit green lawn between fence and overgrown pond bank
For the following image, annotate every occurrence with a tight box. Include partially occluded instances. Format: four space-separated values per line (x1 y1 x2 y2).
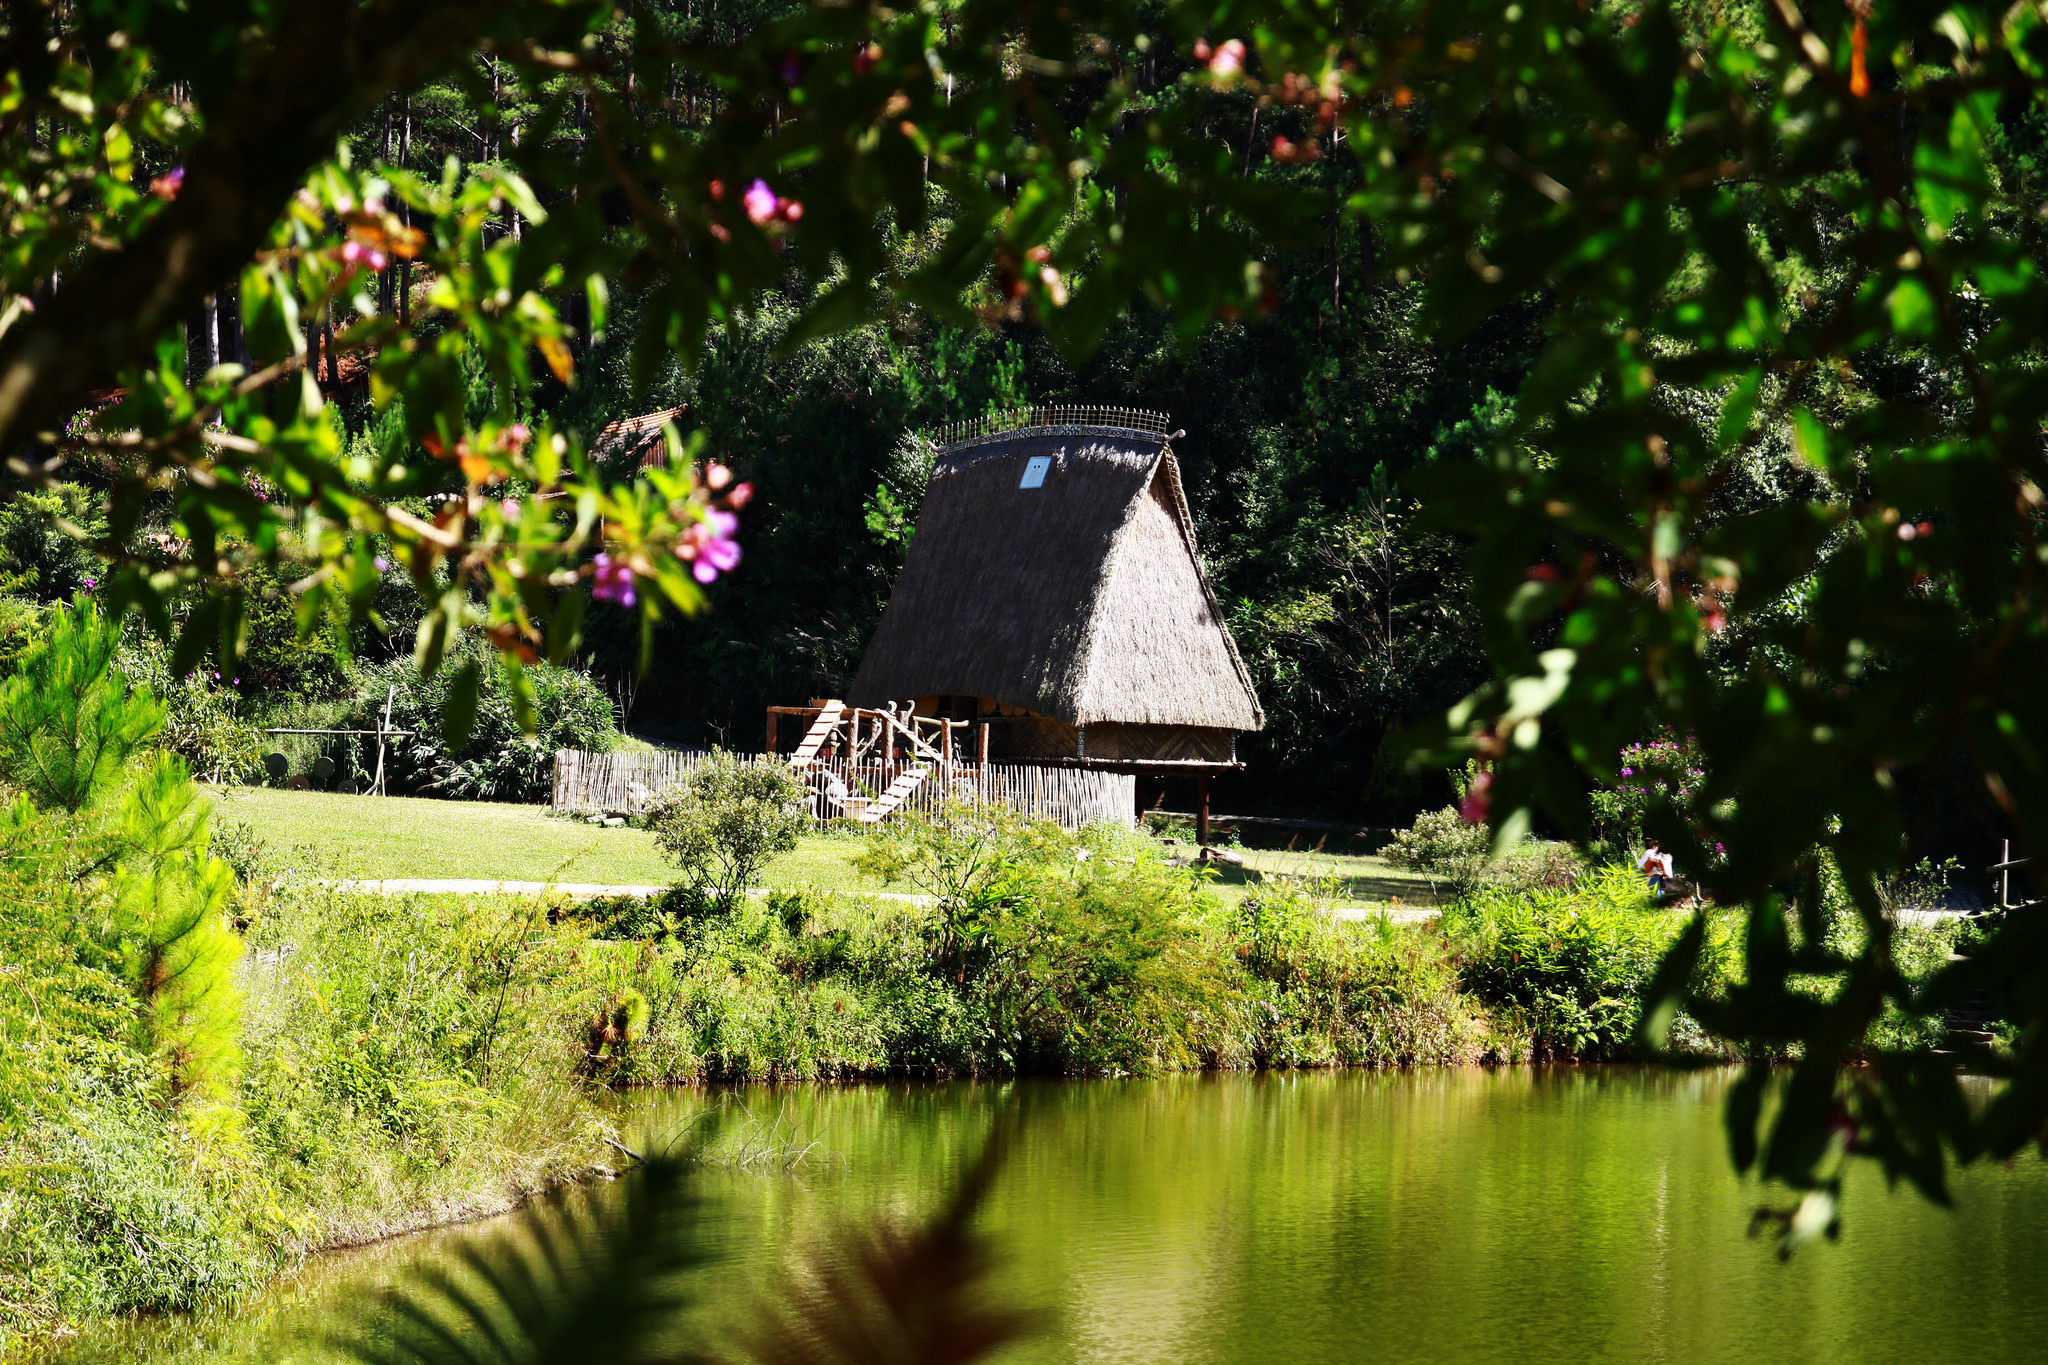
213 786 1434 907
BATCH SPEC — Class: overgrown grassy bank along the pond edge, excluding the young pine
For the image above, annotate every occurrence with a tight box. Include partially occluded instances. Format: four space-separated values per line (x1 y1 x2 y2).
0 806 1948 1345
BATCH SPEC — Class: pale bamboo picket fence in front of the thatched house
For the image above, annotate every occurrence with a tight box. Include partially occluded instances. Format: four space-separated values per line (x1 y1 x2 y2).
551 749 1137 829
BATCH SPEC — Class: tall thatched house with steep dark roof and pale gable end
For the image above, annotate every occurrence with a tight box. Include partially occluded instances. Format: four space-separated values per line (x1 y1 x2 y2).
846 407 1264 769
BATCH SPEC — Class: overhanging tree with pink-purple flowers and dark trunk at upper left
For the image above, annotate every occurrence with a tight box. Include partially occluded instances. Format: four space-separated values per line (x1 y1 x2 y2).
0 0 1311 729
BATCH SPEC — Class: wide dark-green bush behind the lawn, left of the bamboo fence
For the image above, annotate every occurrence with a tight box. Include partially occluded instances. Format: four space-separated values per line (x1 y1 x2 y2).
340 636 618 802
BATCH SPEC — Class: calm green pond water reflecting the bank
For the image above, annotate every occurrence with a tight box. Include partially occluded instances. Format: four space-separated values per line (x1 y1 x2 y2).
51 1068 2048 1365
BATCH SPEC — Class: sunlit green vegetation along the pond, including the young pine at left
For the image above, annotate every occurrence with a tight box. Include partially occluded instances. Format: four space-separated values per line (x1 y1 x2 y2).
0 608 1982 1349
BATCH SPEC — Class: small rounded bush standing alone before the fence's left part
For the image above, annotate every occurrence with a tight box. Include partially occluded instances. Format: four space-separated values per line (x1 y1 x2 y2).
645 749 811 911
